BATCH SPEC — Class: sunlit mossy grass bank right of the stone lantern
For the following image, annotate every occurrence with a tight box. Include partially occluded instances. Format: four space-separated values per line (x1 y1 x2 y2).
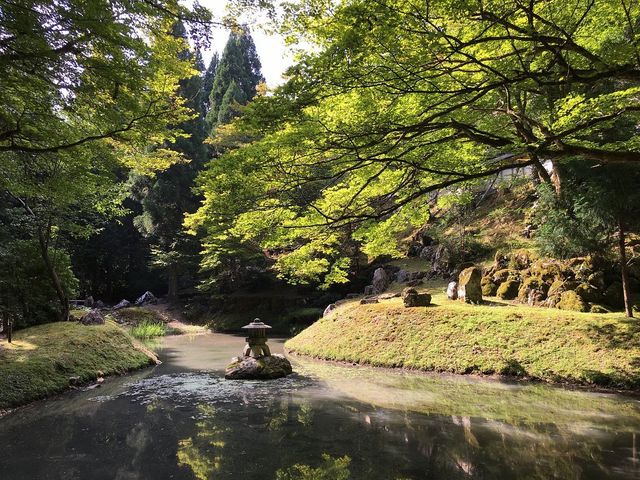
286 284 640 389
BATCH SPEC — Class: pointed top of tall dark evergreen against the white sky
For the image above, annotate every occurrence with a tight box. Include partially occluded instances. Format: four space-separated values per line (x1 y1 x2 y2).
207 28 264 128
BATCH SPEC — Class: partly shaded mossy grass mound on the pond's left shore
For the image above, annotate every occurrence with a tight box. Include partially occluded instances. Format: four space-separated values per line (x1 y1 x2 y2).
0 321 155 409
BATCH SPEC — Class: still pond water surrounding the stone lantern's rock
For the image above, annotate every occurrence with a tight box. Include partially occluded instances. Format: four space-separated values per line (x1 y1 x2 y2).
0 335 640 480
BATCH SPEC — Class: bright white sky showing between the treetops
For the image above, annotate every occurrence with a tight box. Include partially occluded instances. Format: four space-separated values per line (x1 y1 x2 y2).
200 0 293 88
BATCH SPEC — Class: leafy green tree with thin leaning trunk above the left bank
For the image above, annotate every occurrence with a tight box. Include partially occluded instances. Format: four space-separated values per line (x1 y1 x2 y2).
0 0 210 319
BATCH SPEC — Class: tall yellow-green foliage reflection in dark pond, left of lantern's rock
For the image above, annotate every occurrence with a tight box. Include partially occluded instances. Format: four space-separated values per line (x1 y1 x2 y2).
177 404 229 480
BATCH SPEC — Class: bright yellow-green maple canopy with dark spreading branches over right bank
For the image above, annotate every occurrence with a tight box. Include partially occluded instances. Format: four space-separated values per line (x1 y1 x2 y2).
190 0 640 282
